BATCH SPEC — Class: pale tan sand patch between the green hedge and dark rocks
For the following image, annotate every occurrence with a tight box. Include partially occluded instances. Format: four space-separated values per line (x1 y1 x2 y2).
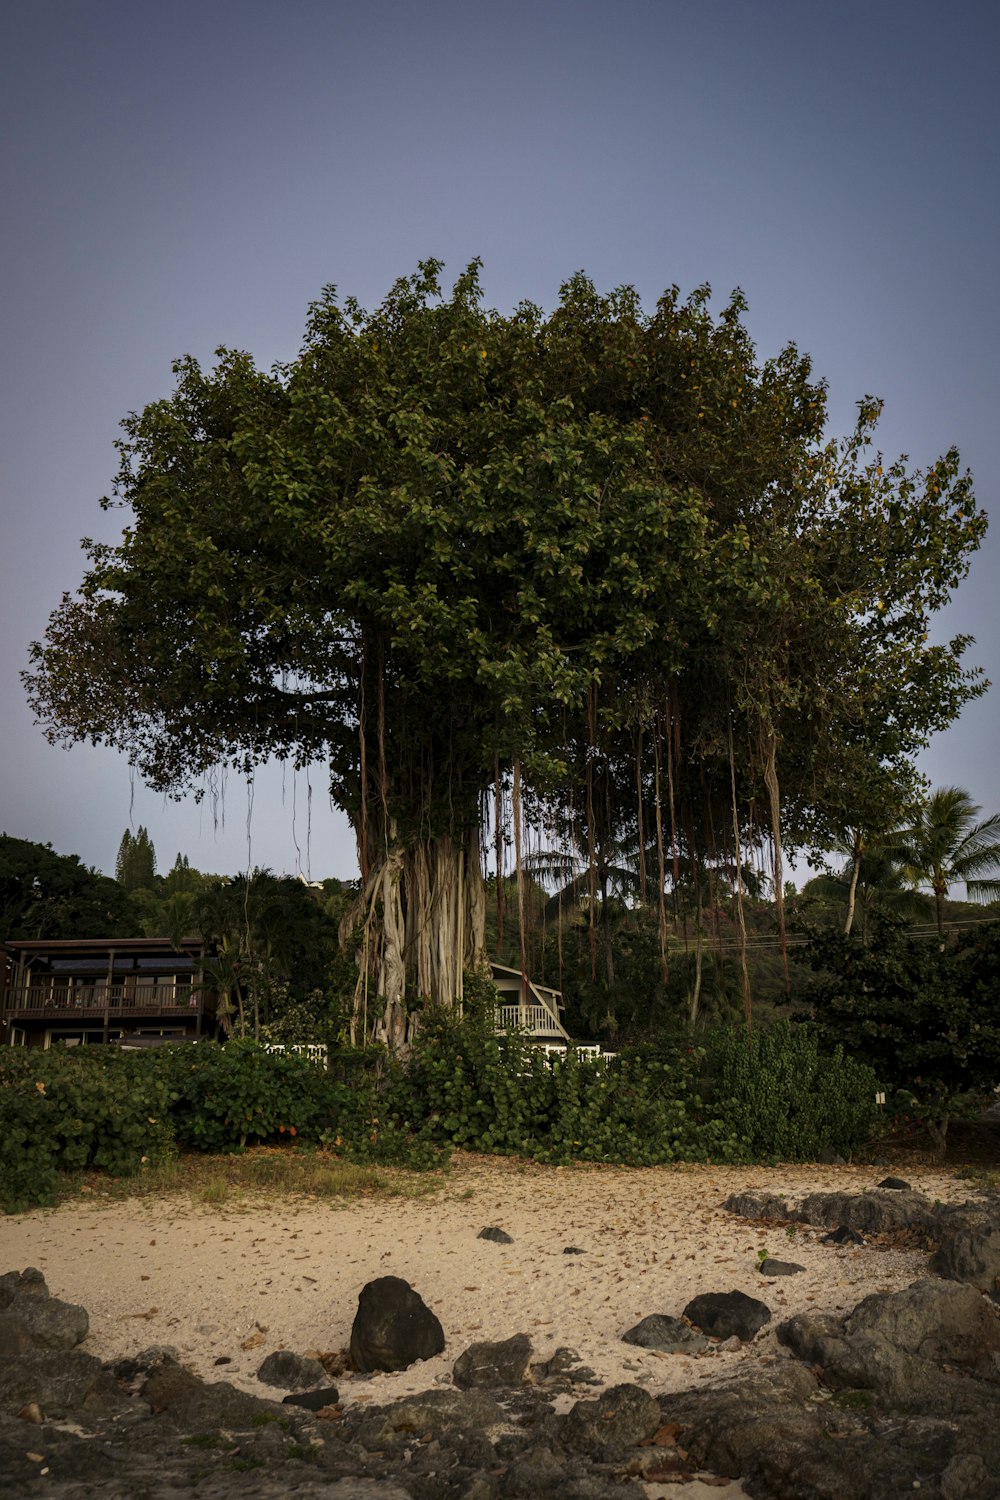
0 1157 970 1496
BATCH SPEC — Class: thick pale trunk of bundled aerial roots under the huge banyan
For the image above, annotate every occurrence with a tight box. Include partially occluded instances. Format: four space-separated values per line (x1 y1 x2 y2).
340 825 486 1053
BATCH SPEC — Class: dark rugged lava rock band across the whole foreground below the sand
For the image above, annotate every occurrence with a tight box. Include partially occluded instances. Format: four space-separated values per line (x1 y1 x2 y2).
0 1254 1000 1500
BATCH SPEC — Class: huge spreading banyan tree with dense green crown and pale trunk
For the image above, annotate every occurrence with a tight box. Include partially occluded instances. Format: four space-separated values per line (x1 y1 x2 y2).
27 261 985 1041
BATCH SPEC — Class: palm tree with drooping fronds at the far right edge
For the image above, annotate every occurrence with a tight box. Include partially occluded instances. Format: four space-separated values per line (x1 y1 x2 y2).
894 786 1000 938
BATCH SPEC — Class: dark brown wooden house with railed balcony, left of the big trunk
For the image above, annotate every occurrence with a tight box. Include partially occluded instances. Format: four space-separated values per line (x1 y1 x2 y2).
0 938 219 1047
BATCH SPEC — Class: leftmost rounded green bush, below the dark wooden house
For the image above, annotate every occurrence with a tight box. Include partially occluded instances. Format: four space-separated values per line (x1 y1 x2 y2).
0 1047 174 1211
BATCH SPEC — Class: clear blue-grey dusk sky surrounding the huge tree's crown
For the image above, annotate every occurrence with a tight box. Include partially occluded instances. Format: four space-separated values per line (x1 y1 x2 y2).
0 0 1000 878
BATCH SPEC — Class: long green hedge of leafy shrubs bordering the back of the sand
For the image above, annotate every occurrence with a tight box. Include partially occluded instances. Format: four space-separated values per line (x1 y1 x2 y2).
0 998 876 1208
